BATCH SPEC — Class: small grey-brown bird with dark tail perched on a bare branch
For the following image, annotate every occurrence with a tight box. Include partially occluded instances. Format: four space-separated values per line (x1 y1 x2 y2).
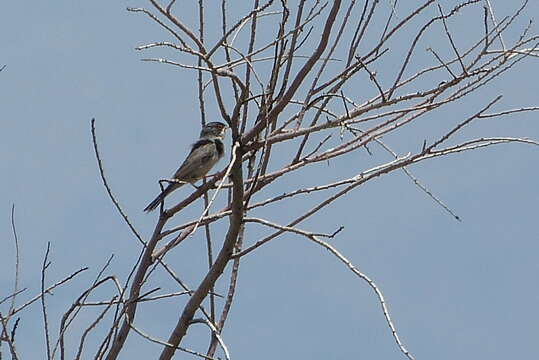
144 122 228 212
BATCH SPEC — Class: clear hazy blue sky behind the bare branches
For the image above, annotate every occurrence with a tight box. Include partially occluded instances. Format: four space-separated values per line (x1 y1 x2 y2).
0 0 539 360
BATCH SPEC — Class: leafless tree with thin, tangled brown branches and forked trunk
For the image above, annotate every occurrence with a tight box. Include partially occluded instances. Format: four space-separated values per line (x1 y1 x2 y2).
2 0 539 360
